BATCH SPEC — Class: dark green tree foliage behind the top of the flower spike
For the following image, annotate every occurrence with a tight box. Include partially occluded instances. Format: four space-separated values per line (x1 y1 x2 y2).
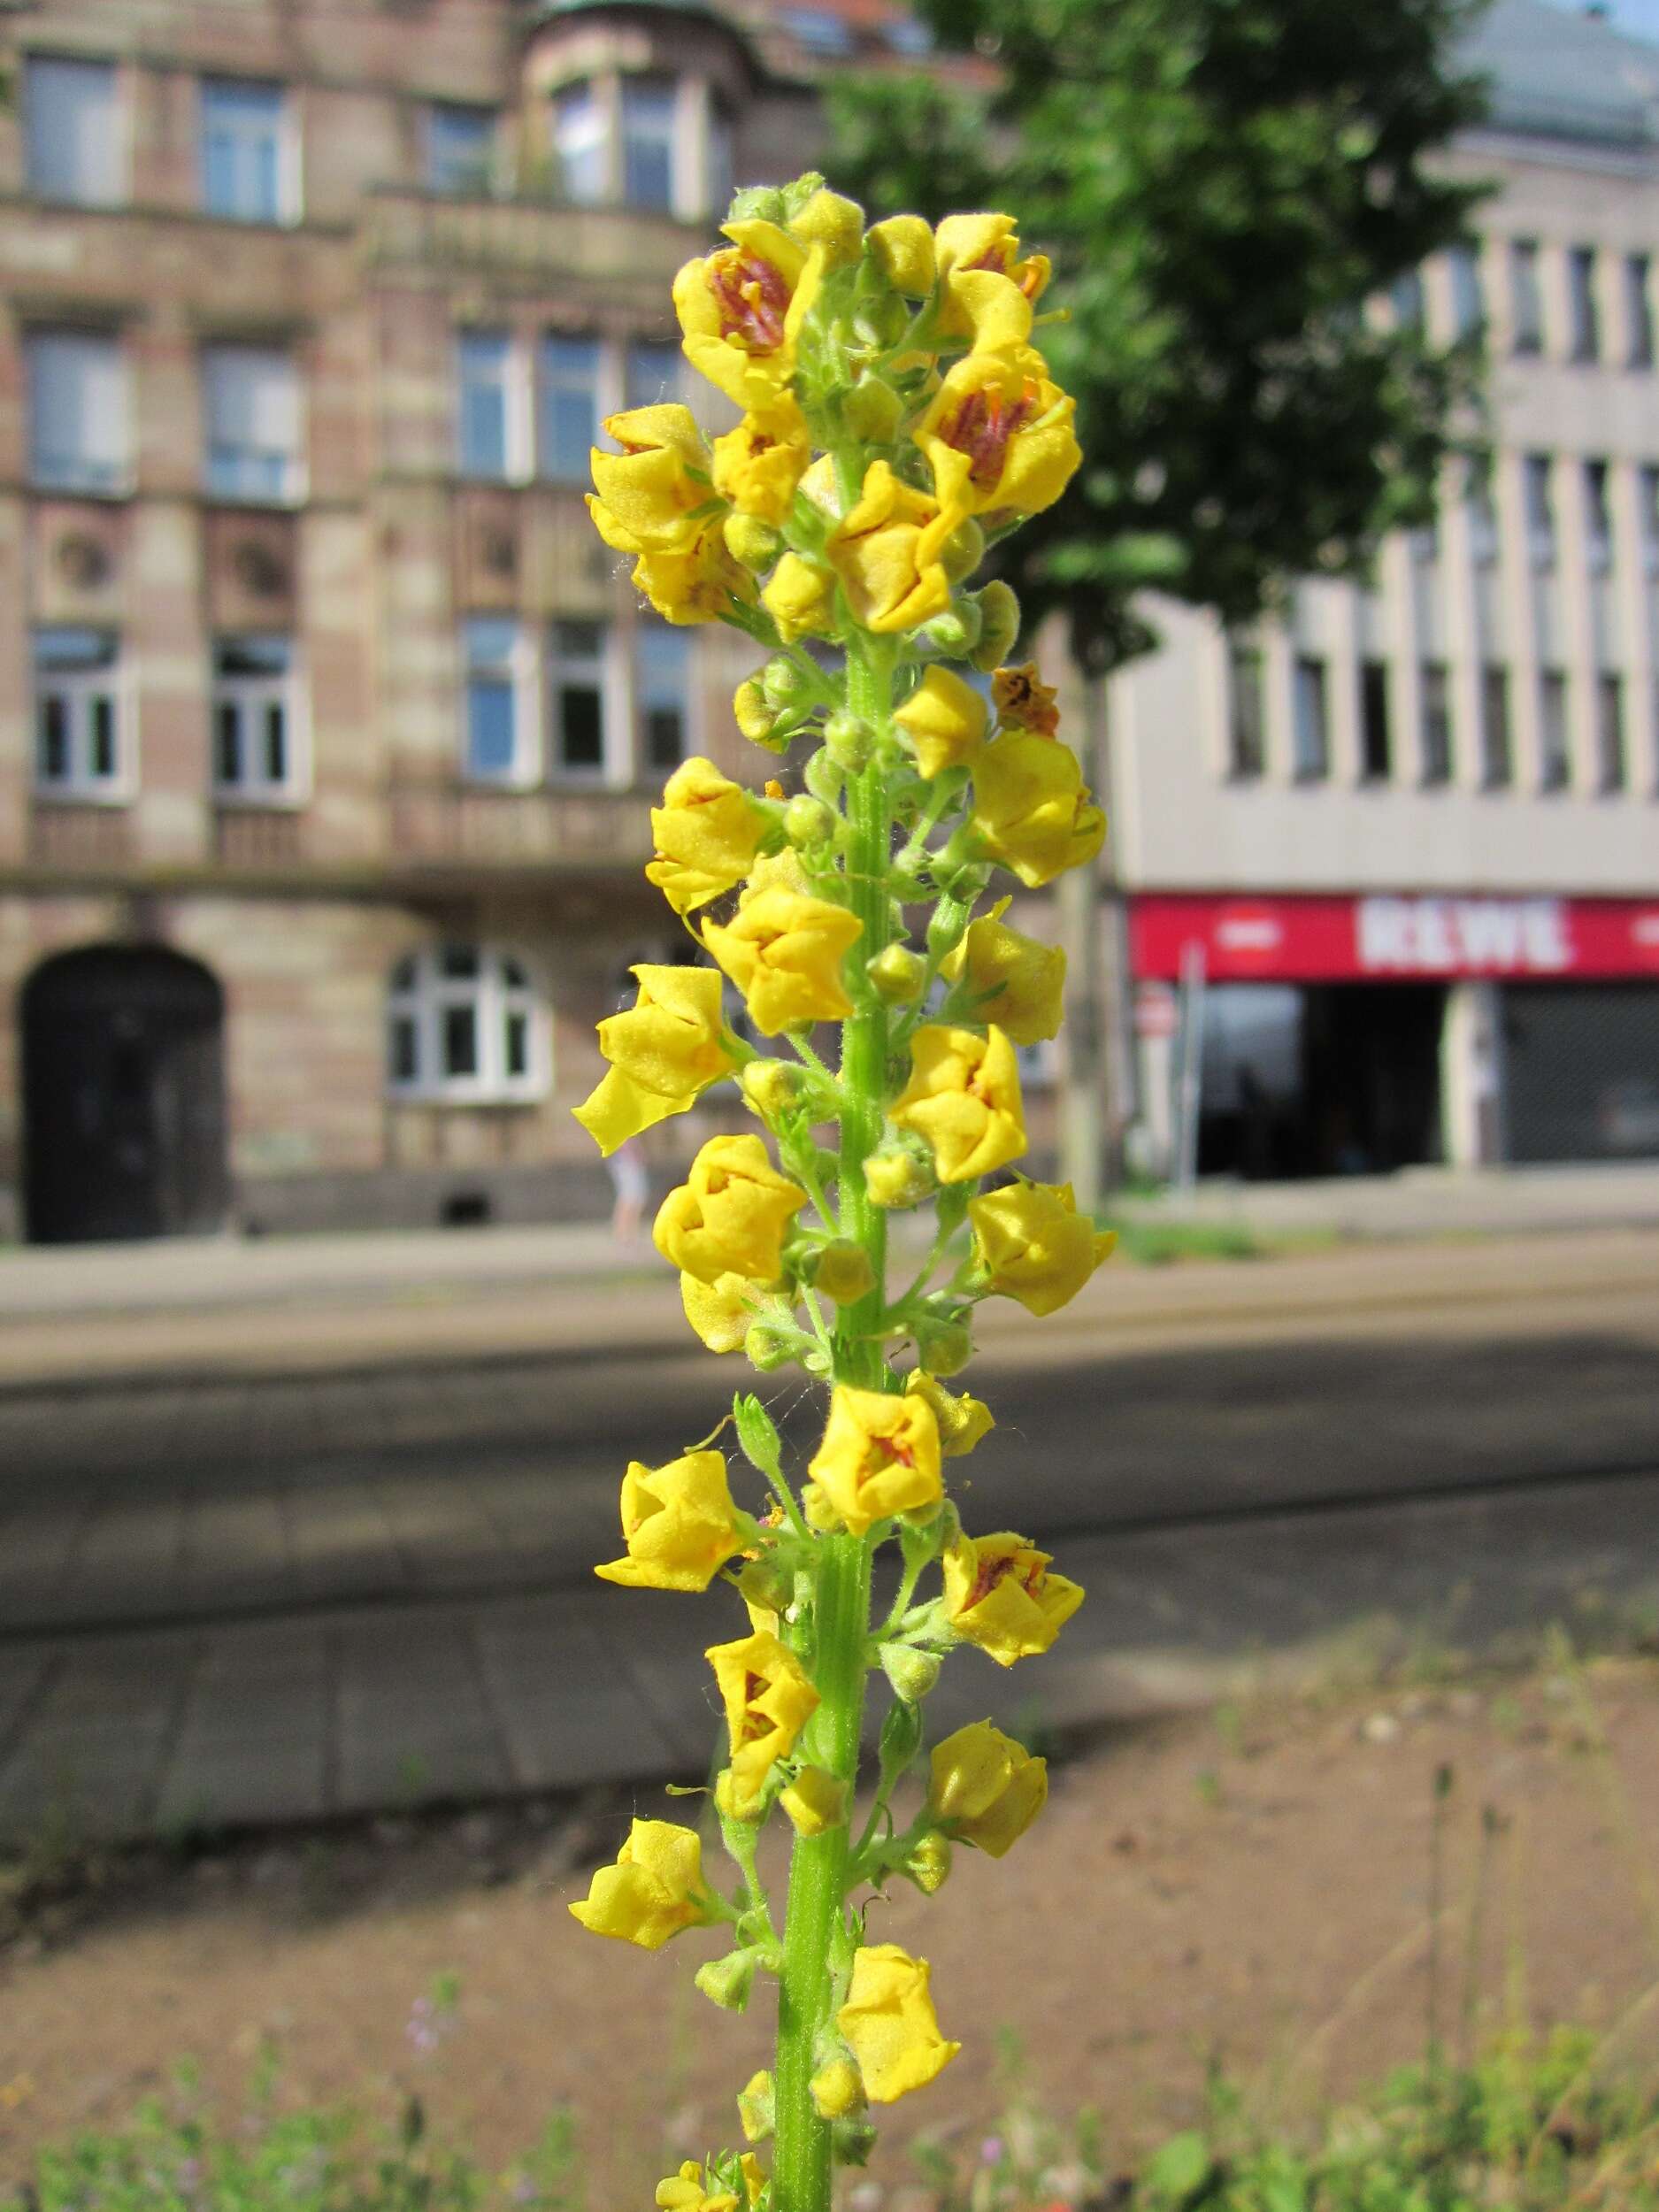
830 0 1485 672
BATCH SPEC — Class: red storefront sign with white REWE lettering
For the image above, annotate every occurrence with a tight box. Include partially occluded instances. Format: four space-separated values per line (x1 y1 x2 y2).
1128 892 1659 982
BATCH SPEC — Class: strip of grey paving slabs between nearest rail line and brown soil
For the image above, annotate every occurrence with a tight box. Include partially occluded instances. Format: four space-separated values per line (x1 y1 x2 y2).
0 1469 1659 1843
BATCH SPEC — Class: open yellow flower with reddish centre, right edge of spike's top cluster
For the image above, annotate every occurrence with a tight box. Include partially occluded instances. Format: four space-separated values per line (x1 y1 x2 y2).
916 348 1084 516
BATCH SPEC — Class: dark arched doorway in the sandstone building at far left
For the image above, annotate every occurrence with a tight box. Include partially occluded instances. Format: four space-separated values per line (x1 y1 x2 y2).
22 945 230 1243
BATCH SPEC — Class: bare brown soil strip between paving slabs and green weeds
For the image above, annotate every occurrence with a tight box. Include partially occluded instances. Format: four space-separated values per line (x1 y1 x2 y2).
0 1659 1659 2206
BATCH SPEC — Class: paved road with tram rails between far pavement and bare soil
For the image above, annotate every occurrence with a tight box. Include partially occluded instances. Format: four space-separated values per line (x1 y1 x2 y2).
0 1234 1659 1830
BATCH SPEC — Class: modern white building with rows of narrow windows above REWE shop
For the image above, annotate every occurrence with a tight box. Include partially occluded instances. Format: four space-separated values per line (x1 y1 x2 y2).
1113 0 1659 1175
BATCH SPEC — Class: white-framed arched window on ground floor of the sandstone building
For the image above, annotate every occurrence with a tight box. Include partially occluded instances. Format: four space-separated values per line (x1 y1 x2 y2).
388 941 553 1106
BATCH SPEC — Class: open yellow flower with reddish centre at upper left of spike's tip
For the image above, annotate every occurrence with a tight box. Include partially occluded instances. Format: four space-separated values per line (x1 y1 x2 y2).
675 221 823 414
